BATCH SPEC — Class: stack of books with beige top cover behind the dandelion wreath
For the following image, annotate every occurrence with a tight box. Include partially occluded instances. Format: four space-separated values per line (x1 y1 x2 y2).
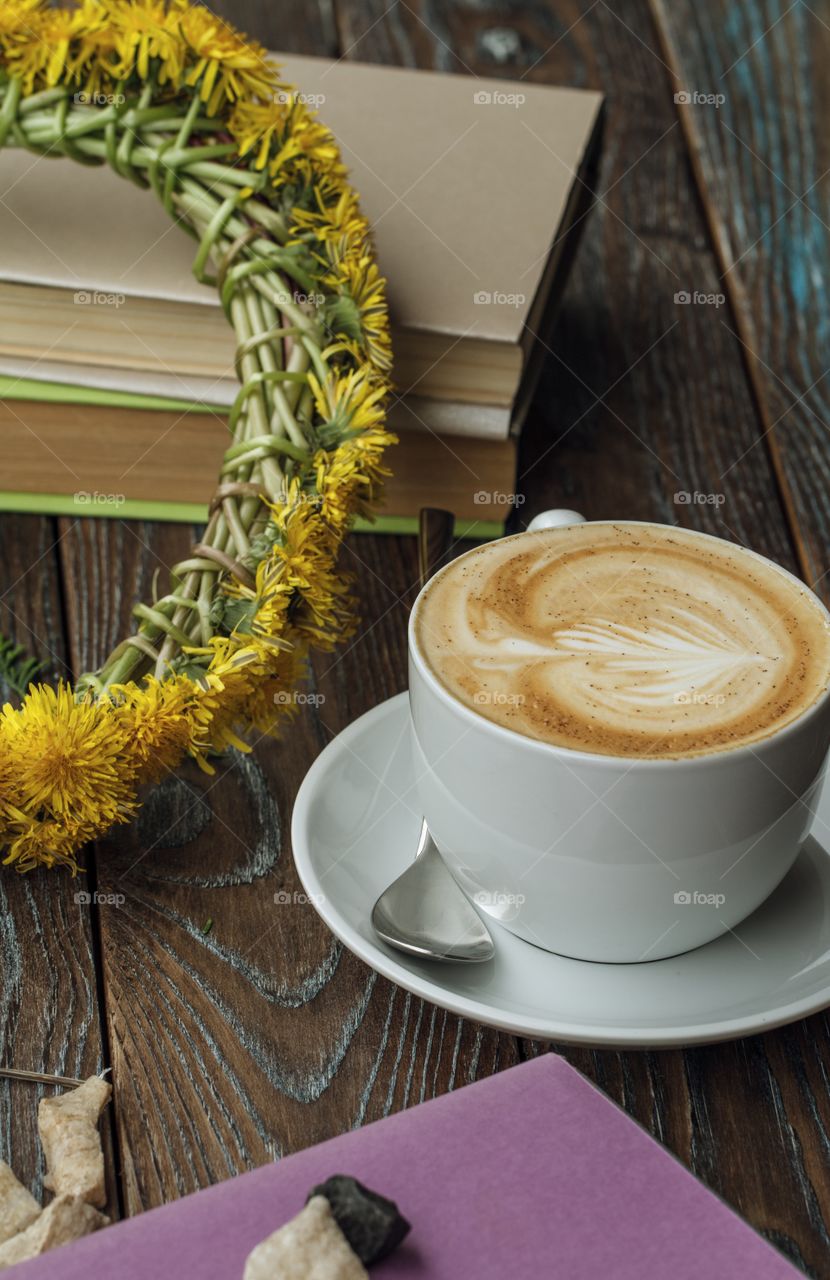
0 54 602 536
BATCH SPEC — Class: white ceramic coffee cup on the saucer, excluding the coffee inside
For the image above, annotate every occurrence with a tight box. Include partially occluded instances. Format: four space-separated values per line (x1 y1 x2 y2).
409 512 830 961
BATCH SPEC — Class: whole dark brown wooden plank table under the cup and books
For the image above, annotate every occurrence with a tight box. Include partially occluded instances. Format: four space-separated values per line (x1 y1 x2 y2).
0 0 830 1276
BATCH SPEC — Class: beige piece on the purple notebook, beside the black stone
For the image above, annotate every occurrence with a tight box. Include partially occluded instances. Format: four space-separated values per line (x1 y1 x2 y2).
243 1196 369 1280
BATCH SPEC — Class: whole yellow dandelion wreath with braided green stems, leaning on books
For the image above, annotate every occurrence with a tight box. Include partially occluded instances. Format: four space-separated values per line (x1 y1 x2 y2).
0 0 392 872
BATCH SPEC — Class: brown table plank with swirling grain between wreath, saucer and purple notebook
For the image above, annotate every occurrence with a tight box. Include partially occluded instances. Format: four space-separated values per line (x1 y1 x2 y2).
64 521 519 1212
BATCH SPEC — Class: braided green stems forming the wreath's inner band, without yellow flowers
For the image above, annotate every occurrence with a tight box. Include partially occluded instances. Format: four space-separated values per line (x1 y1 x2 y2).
0 81 327 691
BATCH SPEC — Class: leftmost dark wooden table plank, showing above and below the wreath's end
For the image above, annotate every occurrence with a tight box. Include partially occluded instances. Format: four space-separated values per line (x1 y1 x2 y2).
0 516 118 1216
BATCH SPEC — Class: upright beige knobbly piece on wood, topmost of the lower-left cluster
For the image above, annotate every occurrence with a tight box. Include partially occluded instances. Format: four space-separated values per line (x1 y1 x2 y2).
37 1075 113 1207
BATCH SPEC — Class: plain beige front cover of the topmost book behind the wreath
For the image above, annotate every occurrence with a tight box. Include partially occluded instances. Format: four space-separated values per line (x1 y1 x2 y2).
0 54 602 356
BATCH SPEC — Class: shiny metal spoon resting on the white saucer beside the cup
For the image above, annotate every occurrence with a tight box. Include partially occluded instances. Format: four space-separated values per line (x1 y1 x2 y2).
371 507 496 963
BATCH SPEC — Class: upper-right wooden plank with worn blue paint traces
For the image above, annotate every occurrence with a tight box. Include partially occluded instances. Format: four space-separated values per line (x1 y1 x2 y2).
653 0 830 599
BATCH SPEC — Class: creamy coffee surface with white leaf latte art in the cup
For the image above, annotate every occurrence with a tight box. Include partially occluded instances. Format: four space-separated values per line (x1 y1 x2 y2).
416 525 830 758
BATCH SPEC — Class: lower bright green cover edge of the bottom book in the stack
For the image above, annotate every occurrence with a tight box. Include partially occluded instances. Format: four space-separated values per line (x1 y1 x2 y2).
0 490 505 541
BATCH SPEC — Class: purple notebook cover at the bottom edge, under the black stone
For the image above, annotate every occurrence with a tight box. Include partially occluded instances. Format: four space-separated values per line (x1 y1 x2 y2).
8 1055 801 1280
